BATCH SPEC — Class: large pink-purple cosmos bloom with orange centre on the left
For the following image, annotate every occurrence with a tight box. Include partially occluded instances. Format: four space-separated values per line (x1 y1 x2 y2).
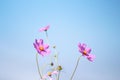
33 39 50 56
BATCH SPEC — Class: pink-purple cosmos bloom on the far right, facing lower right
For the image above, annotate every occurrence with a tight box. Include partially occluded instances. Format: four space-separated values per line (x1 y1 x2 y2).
78 43 95 61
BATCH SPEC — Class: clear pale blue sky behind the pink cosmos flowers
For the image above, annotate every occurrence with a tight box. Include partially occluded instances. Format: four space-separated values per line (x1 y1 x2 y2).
0 0 120 80
